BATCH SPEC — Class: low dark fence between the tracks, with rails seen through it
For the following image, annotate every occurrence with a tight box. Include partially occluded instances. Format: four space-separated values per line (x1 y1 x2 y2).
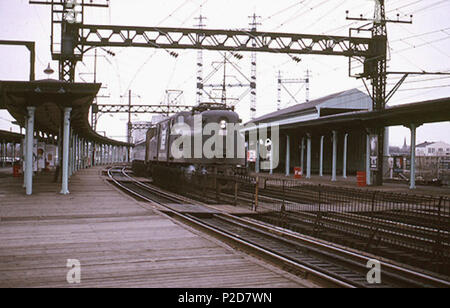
177 174 450 275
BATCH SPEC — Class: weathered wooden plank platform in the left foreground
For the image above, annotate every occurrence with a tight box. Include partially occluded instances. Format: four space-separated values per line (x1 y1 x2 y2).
0 169 314 287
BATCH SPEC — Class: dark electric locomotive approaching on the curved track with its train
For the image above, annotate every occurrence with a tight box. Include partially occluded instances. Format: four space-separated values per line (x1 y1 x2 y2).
132 103 246 184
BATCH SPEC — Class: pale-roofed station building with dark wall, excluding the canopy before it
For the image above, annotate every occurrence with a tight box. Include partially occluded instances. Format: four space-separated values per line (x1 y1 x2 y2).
243 89 372 178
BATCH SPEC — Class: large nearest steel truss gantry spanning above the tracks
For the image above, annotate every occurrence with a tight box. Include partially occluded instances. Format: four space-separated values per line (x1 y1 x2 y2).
30 0 406 185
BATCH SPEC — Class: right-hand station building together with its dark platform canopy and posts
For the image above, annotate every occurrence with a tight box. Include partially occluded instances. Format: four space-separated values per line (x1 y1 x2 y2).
246 89 450 189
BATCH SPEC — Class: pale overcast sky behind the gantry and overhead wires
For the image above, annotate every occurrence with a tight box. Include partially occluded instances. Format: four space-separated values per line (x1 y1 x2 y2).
0 0 450 146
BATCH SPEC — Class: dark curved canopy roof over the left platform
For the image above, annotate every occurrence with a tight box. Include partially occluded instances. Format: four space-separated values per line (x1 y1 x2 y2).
0 79 130 146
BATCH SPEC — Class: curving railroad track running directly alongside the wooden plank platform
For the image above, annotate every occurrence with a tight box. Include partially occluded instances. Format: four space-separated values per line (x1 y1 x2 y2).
107 168 450 288
